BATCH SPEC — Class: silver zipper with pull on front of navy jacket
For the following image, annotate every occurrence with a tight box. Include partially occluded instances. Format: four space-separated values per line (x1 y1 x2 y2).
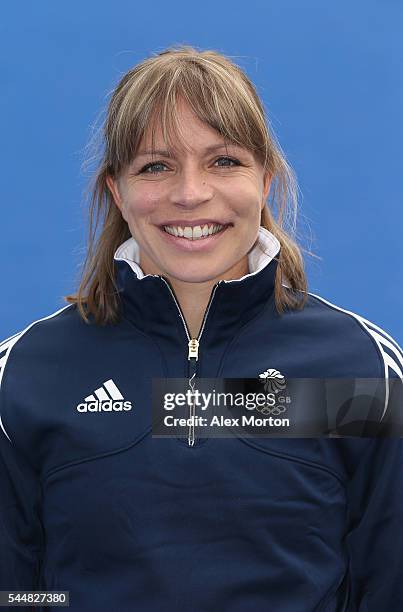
159 274 223 446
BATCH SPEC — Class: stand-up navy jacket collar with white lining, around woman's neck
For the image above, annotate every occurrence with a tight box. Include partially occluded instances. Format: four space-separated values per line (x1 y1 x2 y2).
114 226 280 341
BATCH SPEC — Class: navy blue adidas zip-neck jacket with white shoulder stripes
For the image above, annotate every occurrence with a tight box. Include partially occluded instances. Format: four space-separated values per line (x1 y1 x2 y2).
0 228 403 612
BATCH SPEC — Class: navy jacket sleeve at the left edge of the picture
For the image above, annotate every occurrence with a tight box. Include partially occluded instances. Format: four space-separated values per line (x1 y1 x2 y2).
0 350 43 610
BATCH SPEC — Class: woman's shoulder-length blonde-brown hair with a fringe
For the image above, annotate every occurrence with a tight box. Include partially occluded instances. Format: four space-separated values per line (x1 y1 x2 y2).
64 45 307 325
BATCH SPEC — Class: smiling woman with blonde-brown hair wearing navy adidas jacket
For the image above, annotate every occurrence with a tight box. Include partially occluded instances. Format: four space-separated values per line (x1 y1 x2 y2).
0 46 403 612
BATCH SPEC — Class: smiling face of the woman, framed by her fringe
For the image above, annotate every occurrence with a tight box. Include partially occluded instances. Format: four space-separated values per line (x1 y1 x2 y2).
107 101 270 283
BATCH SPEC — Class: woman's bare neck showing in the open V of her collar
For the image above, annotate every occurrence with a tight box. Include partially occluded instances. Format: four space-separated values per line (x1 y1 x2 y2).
140 255 249 338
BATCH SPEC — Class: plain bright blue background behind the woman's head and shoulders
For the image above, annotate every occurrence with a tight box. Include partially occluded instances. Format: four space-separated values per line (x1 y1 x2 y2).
0 0 403 344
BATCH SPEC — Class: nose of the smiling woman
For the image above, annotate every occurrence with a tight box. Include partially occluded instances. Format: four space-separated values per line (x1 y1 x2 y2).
170 164 213 208
